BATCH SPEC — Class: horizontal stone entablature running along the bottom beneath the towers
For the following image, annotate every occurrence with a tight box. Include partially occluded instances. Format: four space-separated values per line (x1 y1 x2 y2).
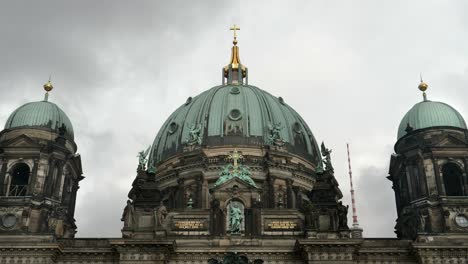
0 236 468 264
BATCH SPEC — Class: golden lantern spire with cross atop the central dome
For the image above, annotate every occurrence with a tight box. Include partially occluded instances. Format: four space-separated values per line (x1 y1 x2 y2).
223 24 248 84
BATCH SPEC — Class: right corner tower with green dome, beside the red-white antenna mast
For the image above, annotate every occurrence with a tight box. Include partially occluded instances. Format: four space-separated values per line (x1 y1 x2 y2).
388 80 468 239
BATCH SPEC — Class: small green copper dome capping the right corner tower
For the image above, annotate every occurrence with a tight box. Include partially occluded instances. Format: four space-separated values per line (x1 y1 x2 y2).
398 100 466 139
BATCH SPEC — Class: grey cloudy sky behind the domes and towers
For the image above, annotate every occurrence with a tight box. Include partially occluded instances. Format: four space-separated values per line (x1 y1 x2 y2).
0 0 468 237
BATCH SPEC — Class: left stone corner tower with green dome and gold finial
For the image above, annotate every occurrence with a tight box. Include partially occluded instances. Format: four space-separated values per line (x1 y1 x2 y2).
0 81 83 239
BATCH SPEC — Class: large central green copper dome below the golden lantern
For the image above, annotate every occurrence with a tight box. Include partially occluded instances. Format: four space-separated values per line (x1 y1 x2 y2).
150 84 320 164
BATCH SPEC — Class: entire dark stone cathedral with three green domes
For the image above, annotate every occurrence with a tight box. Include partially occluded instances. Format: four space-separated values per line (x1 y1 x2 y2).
0 26 468 264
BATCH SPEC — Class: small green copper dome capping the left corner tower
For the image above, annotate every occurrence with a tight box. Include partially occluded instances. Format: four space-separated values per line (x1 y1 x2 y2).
5 101 73 140
